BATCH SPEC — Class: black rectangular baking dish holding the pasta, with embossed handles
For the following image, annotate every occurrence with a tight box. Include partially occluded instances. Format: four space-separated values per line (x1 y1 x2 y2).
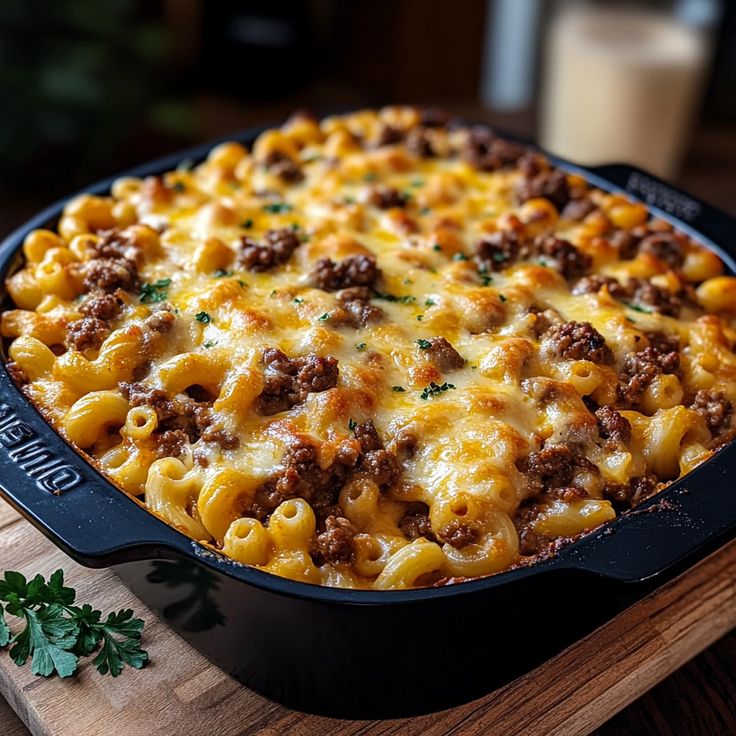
0 126 736 718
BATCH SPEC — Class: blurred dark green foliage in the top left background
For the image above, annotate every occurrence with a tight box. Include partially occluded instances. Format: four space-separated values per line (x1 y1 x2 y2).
0 0 167 182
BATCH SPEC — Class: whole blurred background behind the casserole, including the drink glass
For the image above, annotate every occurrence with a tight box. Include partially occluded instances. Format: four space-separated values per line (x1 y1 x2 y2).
0 0 736 234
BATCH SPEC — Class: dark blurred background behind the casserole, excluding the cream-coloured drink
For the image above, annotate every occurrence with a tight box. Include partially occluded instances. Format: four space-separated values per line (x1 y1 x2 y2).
0 0 736 232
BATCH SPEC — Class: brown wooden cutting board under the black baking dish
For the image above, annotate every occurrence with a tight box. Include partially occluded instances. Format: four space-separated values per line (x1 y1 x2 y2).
0 501 736 736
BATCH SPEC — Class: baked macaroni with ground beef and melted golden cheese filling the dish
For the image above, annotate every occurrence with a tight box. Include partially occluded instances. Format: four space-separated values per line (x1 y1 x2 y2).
2 108 736 589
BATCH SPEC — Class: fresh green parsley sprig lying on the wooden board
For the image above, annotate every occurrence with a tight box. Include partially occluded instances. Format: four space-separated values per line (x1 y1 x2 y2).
0 570 148 677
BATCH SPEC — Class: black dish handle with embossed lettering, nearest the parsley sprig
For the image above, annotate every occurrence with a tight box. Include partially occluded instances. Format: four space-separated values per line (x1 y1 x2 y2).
0 365 191 567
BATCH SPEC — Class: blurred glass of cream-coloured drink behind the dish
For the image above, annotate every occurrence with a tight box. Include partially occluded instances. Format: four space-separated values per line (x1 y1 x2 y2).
541 5 708 177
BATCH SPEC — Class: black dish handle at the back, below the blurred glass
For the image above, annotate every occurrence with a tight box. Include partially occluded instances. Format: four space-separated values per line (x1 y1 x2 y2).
587 164 736 264
